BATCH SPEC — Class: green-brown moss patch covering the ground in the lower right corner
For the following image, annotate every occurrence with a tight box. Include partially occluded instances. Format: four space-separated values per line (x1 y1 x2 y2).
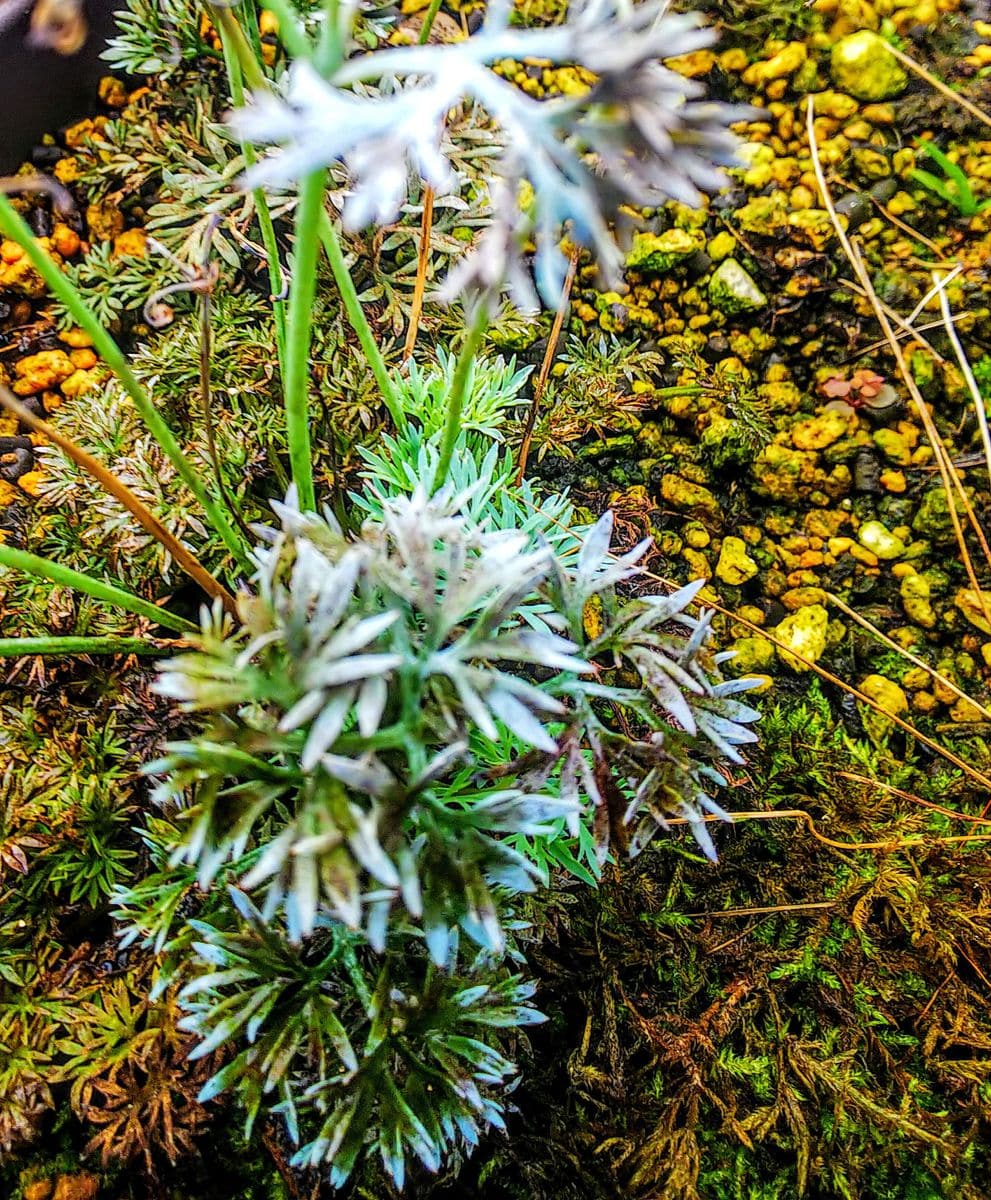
440 684 991 1200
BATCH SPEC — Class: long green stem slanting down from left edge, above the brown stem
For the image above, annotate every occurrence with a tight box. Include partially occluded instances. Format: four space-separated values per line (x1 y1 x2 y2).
0 194 252 572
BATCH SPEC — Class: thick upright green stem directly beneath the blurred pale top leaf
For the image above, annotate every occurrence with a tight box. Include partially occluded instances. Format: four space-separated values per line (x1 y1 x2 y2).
284 168 326 512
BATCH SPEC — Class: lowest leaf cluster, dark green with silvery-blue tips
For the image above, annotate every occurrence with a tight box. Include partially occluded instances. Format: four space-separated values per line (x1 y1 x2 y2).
171 888 543 1188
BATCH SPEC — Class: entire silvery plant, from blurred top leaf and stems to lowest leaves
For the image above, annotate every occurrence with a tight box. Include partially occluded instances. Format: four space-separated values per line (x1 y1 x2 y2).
106 0 757 1186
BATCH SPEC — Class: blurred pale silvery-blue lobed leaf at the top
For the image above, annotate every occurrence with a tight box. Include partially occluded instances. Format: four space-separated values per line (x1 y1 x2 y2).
232 0 741 308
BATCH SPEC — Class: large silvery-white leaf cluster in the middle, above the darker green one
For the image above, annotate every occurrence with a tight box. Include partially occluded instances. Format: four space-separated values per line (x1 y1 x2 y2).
155 485 757 965
